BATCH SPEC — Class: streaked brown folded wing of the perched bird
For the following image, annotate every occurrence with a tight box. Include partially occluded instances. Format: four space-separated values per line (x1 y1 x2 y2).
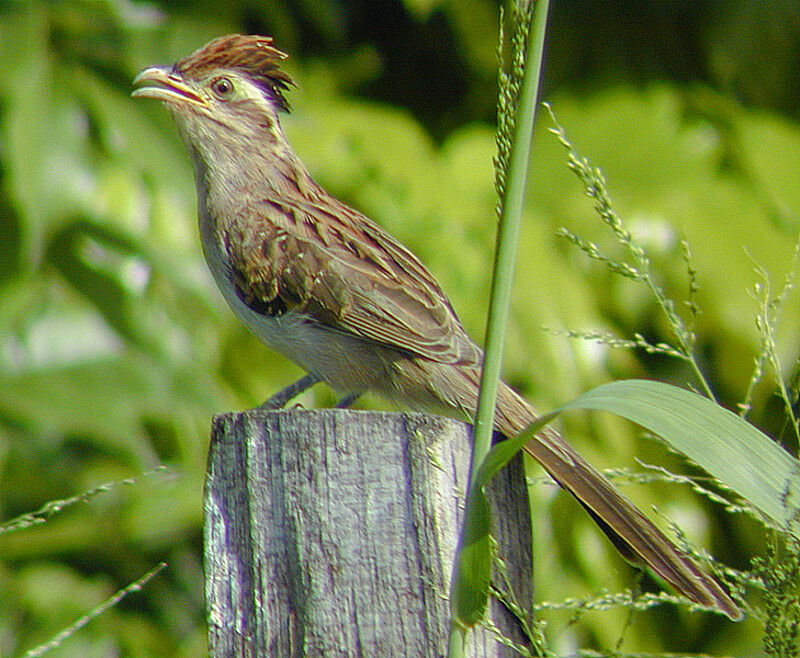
227 199 481 363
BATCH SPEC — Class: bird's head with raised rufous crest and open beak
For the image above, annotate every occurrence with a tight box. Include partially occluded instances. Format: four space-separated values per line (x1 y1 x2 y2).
132 34 293 164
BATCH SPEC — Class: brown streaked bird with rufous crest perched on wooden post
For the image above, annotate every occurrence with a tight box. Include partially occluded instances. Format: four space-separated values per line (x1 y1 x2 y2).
132 34 742 620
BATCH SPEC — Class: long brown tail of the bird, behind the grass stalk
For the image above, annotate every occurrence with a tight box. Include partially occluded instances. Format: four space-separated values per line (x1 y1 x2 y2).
495 385 742 621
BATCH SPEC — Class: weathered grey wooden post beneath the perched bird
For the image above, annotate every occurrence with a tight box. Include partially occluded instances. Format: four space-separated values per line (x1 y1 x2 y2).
205 409 531 657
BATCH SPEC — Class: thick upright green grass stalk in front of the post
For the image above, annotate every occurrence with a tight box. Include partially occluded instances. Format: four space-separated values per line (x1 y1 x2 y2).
448 0 550 658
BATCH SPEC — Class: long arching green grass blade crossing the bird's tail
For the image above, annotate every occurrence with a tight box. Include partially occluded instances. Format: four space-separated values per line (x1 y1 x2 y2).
452 380 800 626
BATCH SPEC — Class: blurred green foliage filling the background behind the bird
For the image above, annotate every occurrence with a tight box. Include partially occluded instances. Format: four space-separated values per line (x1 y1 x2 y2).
0 0 800 657
